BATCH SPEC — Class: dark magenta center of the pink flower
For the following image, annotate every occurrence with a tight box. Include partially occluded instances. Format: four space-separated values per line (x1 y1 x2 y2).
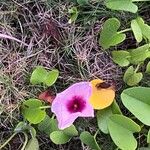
67 96 86 113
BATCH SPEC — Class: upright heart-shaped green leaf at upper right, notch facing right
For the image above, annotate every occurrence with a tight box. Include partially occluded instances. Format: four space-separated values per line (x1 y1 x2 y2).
99 18 126 49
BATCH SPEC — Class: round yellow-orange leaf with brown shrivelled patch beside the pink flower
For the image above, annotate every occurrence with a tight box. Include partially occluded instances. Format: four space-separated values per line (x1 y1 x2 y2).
90 79 115 109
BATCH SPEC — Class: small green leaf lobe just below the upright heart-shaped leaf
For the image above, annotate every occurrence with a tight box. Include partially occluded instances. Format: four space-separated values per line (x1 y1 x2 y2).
112 50 130 67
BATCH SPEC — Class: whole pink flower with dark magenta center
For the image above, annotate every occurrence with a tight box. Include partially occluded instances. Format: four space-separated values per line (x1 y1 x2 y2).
51 82 94 129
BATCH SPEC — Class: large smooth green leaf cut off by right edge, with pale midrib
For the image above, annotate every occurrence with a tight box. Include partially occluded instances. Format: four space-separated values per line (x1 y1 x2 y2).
121 87 150 126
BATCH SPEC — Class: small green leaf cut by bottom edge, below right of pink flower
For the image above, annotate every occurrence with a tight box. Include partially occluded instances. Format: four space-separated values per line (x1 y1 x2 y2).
80 131 101 150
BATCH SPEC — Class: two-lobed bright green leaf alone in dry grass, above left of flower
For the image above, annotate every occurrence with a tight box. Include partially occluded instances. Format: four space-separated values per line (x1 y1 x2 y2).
30 66 59 86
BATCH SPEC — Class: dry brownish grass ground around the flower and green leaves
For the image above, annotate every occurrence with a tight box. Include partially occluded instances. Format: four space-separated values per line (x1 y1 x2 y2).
0 0 150 150
